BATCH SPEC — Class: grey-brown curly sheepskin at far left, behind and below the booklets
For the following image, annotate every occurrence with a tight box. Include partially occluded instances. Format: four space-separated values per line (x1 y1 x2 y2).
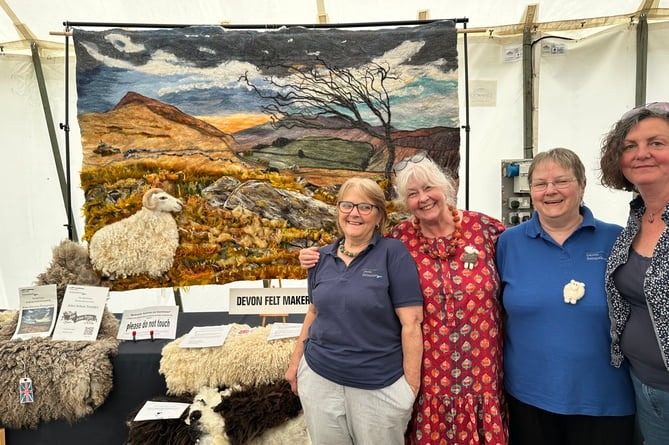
0 240 119 428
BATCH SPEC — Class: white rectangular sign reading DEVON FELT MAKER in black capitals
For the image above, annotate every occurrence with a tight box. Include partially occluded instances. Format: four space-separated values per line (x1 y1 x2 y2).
229 287 310 314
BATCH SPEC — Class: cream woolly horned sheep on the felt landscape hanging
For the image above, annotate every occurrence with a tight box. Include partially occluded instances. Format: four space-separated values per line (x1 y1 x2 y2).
88 188 183 280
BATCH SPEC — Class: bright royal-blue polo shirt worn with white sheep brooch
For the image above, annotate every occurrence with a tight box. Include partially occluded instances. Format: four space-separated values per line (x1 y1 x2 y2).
497 207 634 416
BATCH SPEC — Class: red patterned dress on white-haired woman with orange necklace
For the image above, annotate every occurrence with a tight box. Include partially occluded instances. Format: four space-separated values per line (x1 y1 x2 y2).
388 211 508 445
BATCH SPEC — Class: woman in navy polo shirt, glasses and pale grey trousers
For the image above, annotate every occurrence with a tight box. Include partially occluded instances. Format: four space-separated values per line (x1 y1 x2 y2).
286 178 423 445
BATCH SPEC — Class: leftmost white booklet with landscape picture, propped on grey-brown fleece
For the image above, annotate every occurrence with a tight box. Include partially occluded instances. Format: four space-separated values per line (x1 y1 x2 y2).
12 284 58 340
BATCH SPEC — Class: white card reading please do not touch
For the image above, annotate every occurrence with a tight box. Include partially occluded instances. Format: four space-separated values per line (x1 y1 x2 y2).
116 306 179 340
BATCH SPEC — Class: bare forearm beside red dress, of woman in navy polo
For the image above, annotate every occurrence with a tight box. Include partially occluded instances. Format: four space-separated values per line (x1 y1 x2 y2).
395 306 423 395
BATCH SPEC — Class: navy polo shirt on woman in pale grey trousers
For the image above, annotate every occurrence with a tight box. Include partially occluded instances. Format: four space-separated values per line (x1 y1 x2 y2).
304 233 423 389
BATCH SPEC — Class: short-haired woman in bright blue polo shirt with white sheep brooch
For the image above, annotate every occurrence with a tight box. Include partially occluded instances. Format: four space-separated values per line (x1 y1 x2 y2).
497 148 635 445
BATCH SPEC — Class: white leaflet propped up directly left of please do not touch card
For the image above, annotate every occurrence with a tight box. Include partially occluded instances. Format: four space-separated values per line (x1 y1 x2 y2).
53 284 109 341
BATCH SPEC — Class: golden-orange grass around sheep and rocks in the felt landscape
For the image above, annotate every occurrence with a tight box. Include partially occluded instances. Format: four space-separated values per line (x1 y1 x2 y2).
81 159 334 291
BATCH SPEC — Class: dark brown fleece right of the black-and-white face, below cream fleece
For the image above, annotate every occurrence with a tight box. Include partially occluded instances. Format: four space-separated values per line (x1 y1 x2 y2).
214 380 302 445
